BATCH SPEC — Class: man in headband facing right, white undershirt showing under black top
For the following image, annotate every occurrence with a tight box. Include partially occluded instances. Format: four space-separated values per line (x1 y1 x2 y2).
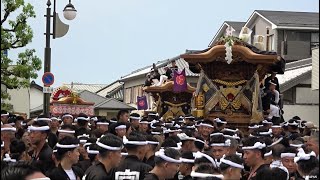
47 136 84 180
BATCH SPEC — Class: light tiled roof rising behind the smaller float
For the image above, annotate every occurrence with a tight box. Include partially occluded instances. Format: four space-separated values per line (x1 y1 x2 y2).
121 56 199 80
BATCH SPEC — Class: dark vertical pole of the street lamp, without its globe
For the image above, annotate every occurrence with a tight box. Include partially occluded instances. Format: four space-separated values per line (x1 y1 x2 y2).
43 0 51 117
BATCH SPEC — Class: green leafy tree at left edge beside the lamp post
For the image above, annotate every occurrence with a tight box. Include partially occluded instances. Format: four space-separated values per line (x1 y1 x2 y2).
1 0 42 110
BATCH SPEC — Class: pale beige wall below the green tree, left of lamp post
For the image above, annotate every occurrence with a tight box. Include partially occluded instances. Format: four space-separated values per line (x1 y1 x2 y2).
6 88 30 117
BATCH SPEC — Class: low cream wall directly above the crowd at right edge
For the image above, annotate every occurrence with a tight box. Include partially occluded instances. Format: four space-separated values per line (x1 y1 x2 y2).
283 105 319 127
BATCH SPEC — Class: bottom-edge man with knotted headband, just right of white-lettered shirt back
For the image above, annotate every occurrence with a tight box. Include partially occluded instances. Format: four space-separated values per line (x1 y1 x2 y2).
144 148 181 180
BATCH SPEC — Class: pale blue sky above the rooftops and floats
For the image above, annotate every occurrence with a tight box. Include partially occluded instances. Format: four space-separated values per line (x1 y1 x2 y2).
9 0 319 87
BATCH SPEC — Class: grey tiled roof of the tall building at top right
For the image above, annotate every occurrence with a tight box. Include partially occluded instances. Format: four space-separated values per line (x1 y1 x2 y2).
256 10 319 28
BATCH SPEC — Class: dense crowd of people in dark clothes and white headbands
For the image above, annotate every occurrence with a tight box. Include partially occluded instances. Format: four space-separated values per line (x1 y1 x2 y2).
1 110 319 180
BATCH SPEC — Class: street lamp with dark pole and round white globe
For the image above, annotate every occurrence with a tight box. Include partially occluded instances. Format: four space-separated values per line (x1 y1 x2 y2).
43 0 77 117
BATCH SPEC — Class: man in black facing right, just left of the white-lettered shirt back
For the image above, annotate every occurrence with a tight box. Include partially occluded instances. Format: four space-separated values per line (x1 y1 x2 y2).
83 134 123 180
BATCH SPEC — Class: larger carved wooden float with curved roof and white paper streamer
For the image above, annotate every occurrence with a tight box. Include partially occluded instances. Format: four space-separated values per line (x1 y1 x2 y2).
180 36 285 128
